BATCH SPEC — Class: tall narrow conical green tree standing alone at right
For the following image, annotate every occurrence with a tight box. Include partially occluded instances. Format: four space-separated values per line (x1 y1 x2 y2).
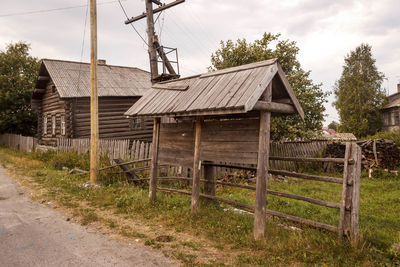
334 44 385 137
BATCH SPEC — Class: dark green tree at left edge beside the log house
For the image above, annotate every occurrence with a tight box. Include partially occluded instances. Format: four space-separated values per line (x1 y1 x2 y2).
0 42 40 135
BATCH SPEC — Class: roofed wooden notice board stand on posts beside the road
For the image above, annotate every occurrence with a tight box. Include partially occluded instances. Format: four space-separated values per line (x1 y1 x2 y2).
125 59 304 239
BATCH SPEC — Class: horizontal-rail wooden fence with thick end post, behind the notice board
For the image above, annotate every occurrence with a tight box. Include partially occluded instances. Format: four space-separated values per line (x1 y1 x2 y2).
152 143 361 244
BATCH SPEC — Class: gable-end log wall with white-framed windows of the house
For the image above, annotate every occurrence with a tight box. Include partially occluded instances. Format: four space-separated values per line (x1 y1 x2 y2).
36 80 68 146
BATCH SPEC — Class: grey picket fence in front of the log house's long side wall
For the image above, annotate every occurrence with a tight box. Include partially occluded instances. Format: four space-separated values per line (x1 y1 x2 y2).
57 138 151 160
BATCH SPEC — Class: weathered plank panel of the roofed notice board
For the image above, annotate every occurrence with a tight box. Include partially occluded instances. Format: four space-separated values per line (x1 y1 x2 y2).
158 119 259 168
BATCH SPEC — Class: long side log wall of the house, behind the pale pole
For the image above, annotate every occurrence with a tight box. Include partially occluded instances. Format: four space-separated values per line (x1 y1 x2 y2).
69 97 153 141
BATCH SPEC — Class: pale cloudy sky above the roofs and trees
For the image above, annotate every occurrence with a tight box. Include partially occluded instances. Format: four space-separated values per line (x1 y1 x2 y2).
0 0 400 125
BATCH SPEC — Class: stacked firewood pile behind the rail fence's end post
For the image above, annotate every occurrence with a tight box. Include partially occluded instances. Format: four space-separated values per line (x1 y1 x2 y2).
326 139 400 170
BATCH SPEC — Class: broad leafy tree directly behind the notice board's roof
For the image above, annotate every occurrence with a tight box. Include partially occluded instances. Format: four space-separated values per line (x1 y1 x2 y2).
209 33 327 140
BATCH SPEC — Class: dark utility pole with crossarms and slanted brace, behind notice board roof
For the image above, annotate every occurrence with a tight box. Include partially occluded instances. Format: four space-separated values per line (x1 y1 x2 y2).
125 0 185 83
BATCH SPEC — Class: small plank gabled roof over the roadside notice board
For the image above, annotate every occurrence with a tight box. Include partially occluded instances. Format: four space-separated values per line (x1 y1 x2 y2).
125 59 304 118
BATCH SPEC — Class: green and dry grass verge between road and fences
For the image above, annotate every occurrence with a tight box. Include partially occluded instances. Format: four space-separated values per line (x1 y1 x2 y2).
0 148 400 266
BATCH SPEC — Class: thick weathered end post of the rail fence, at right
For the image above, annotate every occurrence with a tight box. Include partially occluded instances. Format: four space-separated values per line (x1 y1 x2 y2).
339 143 361 246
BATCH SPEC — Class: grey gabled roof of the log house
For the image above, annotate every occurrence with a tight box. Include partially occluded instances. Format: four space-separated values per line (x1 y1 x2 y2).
33 59 151 98
